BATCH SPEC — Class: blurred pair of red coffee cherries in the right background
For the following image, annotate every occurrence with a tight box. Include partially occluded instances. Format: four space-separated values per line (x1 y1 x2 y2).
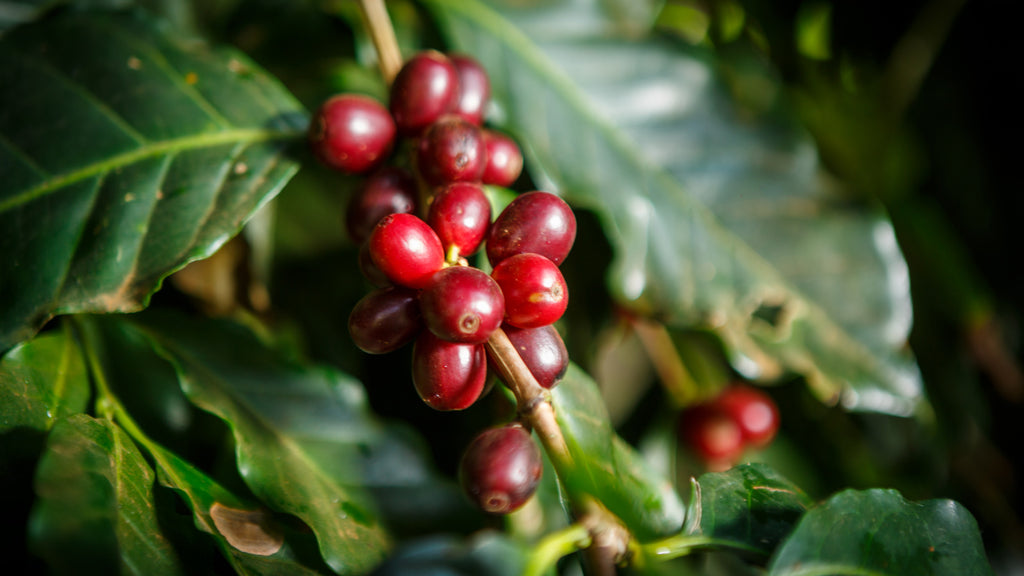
679 382 779 470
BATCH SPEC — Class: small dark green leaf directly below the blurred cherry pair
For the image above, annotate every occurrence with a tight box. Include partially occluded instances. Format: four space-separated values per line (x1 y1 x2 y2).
687 464 814 556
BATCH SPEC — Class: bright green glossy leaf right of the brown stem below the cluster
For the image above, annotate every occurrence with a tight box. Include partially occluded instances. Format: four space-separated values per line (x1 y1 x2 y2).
552 364 683 541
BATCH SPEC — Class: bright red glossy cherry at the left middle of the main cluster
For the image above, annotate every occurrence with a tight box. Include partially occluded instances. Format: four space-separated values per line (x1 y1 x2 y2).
368 214 444 289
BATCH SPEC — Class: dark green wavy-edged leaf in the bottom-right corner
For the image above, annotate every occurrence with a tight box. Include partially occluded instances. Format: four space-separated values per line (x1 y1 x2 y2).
768 490 992 576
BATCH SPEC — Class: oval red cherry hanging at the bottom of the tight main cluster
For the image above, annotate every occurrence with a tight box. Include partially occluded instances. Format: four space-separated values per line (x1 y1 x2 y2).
413 330 487 410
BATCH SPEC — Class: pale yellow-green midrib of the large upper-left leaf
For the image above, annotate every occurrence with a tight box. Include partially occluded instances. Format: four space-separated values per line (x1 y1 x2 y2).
0 128 305 213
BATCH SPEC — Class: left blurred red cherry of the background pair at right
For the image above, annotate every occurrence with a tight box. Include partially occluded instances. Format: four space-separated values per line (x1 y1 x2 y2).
680 405 743 470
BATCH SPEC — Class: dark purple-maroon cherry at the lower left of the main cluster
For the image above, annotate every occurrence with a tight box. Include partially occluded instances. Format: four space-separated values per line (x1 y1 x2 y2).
348 286 423 354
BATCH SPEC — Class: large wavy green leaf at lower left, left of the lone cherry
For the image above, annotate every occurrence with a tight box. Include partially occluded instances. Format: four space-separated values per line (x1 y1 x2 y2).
119 314 465 574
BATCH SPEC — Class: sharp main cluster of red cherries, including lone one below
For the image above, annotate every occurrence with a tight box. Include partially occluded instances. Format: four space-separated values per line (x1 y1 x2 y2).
309 50 575 512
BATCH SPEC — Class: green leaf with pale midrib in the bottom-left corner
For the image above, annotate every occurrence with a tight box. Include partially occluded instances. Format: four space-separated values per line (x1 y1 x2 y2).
29 414 183 575
